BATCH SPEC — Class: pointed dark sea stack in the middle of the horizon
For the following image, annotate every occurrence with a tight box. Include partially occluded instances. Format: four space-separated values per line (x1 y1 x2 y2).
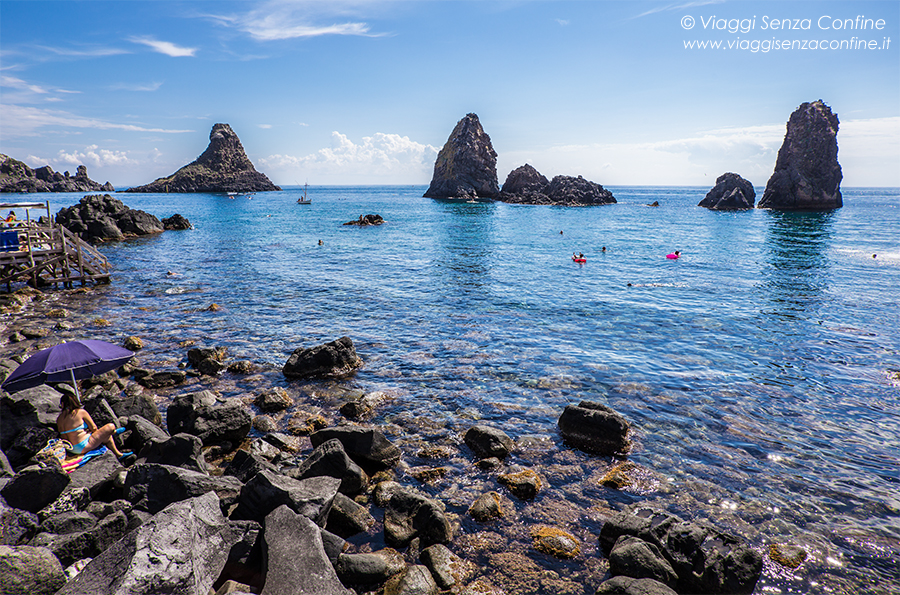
424 114 500 199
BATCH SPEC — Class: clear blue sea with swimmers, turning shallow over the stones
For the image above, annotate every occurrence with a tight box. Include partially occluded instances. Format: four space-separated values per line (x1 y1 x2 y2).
0 186 900 595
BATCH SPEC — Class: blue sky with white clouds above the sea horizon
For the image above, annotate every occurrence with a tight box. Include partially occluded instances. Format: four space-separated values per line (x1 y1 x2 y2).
0 0 900 186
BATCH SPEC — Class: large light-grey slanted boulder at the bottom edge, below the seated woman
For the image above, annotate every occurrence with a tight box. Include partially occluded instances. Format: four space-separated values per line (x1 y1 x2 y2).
59 493 250 595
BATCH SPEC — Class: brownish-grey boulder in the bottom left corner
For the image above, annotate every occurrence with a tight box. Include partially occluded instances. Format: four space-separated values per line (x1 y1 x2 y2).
0 548 66 595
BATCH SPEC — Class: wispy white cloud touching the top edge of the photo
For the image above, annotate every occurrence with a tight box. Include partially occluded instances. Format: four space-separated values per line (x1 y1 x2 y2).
206 0 378 41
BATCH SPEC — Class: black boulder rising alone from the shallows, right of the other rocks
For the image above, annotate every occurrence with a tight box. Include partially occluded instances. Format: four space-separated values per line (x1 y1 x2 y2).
558 401 630 455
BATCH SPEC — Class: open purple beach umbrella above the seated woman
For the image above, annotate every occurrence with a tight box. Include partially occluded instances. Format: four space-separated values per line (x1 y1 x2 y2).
0 339 134 401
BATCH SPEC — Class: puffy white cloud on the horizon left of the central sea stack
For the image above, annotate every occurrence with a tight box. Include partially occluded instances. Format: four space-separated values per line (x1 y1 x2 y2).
260 132 438 184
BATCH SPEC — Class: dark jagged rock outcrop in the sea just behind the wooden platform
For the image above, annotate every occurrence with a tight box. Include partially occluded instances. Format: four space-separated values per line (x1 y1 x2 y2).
56 194 164 243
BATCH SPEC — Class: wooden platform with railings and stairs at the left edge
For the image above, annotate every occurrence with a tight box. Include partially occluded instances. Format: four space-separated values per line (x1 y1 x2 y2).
0 203 110 291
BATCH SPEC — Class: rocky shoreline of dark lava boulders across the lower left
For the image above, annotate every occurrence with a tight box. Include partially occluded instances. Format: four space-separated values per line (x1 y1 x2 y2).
0 288 805 595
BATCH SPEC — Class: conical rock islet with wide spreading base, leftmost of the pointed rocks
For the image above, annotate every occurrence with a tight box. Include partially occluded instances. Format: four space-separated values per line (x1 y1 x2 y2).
125 124 281 192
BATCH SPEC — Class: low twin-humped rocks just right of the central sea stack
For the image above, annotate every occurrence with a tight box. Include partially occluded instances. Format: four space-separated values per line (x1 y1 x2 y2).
499 163 616 207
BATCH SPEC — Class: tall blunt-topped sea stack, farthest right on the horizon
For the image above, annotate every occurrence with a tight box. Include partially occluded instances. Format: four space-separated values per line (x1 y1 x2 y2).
757 99 844 210
